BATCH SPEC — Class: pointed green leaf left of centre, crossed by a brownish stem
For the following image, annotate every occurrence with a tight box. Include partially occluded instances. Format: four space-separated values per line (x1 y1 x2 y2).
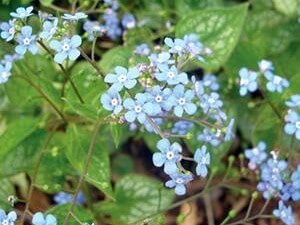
65 125 113 198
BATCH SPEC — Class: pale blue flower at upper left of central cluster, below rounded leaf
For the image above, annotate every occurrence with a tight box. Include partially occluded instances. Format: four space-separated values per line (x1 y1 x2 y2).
104 66 139 91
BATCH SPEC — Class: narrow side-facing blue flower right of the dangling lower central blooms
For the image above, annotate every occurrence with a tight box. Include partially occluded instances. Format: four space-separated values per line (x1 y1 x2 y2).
194 145 210 178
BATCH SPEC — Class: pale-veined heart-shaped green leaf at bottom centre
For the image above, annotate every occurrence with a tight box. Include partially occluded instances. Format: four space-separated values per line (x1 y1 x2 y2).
97 175 174 224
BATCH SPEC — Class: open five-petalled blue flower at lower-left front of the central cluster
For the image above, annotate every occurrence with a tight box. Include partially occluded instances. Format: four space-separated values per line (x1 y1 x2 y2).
123 93 153 124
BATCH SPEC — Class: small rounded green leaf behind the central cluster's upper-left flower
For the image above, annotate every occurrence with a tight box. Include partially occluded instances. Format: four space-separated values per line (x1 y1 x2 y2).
99 46 131 73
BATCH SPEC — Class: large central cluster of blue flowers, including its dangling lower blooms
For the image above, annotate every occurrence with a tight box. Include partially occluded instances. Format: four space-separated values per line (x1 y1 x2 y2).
100 34 234 195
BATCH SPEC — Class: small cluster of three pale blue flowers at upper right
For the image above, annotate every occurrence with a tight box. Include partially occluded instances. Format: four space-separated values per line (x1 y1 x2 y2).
239 60 289 96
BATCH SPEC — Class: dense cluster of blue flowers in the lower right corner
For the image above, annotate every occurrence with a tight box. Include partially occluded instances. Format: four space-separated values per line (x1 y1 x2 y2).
245 142 300 225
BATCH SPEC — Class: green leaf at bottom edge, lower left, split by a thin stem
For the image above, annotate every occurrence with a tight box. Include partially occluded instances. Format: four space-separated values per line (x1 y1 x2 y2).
46 204 94 225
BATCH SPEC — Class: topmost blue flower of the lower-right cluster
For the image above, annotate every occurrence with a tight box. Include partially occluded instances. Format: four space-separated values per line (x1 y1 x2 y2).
245 141 267 170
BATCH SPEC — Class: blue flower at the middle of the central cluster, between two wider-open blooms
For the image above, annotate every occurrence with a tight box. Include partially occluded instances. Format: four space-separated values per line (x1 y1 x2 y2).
148 85 172 114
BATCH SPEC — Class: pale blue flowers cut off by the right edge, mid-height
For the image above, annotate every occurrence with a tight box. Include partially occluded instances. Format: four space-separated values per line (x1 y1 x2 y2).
284 95 300 140
